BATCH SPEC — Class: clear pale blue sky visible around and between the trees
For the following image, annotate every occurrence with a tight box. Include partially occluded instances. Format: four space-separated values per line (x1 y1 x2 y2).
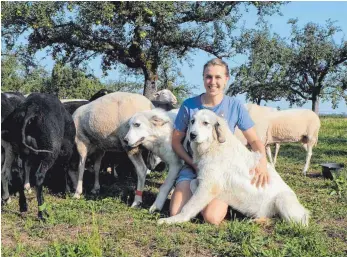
30 1 347 114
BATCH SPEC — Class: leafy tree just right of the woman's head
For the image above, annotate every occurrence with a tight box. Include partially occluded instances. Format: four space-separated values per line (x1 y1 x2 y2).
227 25 288 105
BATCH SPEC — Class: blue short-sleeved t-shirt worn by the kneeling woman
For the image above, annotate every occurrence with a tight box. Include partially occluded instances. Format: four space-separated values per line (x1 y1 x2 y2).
174 95 254 133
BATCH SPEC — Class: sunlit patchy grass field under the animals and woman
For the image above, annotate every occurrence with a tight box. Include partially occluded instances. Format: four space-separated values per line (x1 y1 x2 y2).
1 117 347 257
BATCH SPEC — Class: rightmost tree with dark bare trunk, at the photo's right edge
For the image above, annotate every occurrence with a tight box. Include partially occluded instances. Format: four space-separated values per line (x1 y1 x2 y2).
284 20 347 113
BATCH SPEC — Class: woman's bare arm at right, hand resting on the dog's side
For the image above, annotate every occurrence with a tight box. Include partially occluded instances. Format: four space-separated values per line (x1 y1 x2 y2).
243 127 270 187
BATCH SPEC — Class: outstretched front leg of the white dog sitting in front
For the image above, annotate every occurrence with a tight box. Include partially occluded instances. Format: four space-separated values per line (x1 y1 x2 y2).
158 182 220 224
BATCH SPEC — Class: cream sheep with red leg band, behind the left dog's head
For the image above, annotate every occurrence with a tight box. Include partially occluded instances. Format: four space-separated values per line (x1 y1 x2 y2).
73 92 154 207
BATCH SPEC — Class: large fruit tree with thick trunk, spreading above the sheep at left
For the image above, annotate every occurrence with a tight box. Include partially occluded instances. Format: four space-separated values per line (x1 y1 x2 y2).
2 1 282 98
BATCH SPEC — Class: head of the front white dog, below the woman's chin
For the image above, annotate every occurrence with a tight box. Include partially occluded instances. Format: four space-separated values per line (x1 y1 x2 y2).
187 109 226 144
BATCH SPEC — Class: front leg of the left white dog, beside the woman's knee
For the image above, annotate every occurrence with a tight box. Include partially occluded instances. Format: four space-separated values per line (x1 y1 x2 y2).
149 164 180 213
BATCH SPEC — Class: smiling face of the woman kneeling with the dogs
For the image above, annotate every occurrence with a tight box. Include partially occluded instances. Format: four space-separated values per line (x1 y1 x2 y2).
204 65 229 96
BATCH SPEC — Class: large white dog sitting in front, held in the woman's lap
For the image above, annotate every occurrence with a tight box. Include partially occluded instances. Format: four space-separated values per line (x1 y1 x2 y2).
158 110 309 226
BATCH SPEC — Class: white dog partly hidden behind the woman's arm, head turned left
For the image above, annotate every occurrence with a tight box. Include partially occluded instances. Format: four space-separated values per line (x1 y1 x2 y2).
124 108 183 212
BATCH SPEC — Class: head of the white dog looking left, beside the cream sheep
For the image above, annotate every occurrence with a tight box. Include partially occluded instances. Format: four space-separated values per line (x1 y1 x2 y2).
124 109 171 147
